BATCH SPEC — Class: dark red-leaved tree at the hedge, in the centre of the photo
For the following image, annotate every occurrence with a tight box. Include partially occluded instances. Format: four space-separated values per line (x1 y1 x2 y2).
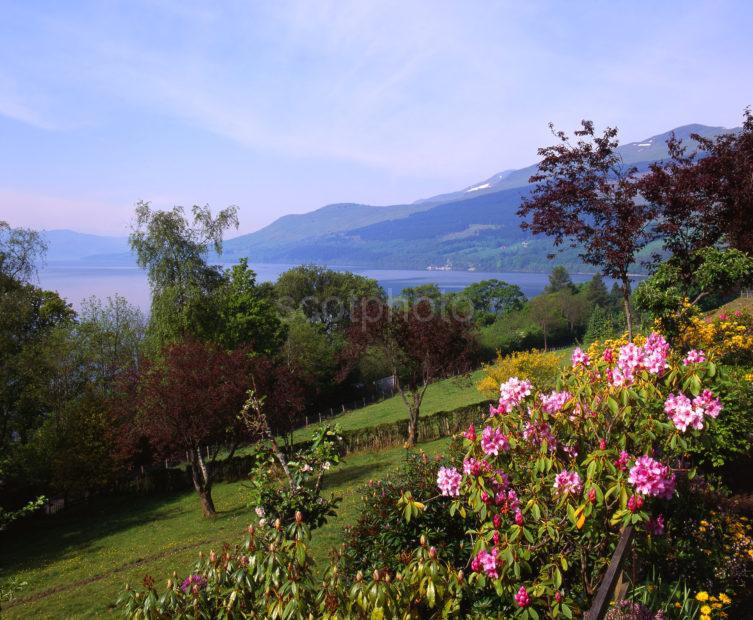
341 299 478 446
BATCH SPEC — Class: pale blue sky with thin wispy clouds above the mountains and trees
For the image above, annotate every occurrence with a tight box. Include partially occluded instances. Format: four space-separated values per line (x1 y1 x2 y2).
0 0 753 236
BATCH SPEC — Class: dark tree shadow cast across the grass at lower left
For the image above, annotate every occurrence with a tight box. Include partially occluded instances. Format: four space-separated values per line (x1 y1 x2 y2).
0 492 246 579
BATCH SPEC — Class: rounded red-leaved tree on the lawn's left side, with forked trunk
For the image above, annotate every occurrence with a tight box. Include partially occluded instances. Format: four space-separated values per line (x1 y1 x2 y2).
135 341 251 516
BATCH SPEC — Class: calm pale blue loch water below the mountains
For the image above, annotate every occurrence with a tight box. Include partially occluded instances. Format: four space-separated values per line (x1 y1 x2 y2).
39 263 636 310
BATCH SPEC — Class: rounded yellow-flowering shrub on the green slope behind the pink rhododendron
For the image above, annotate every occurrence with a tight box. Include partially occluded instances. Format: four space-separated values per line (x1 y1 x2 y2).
477 349 562 392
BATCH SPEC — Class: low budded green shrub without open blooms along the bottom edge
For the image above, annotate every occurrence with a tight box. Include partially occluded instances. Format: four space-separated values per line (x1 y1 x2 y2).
118 513 467 620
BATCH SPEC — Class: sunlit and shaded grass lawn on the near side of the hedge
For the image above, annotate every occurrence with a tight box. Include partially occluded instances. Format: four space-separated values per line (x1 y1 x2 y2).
0 439 449 618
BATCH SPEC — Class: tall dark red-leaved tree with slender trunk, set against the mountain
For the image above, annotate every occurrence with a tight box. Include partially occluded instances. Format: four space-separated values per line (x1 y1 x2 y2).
518 120 656 338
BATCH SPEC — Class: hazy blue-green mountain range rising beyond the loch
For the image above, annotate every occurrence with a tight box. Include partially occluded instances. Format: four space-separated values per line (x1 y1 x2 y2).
51 124 736 271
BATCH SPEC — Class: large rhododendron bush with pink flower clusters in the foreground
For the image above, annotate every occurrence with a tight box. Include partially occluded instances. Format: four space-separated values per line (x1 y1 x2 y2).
426 333 722 618
